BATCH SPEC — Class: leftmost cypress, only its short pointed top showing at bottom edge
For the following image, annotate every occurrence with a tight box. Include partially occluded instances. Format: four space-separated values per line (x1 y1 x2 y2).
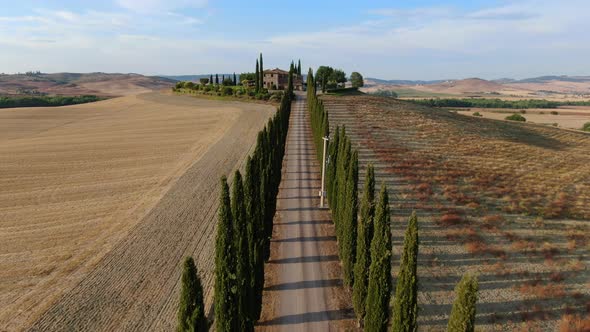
176 257 209 332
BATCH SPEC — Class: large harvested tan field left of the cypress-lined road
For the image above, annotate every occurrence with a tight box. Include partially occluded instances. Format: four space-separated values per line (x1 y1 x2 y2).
0 93 274 331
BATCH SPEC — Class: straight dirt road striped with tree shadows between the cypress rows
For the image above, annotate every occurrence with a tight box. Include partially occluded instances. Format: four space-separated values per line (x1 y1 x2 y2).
257 96 353 331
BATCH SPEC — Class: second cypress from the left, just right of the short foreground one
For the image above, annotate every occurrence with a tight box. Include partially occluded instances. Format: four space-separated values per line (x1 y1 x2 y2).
215 176 239 332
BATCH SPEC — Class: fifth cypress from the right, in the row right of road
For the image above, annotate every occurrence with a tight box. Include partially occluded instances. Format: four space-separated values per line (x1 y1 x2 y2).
341 150 358 287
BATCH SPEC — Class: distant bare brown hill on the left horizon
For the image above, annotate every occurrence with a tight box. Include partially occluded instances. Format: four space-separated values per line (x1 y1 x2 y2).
0 73 175 96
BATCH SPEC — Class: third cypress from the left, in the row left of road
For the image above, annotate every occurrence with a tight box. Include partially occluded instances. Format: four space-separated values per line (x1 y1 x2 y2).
231 171 254 331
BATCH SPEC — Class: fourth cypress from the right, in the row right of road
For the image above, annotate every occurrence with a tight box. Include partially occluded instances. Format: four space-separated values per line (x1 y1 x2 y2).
352 164 375 322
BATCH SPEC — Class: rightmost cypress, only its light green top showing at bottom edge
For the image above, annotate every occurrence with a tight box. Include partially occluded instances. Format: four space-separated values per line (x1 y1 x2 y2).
447 274 479 332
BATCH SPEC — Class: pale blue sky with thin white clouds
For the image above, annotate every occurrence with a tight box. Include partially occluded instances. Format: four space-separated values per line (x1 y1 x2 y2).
0 0 590 80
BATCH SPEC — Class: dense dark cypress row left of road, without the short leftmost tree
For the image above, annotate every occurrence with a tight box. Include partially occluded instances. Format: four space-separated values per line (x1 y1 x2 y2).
215 74 291 331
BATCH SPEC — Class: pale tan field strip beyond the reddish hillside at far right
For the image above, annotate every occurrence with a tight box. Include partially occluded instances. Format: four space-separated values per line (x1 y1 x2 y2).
455 107 590 130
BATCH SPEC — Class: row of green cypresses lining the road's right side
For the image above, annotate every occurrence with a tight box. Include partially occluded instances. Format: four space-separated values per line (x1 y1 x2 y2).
307 69 477 332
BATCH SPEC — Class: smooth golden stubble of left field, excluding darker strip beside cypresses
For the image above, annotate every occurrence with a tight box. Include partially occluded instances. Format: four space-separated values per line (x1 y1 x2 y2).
0 94 272 331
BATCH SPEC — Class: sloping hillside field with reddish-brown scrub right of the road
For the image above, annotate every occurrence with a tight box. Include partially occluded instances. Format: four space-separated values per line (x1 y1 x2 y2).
323 96 590 331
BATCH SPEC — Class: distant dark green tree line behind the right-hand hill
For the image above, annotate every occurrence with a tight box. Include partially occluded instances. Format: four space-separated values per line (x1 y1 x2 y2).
411 98 590 109
